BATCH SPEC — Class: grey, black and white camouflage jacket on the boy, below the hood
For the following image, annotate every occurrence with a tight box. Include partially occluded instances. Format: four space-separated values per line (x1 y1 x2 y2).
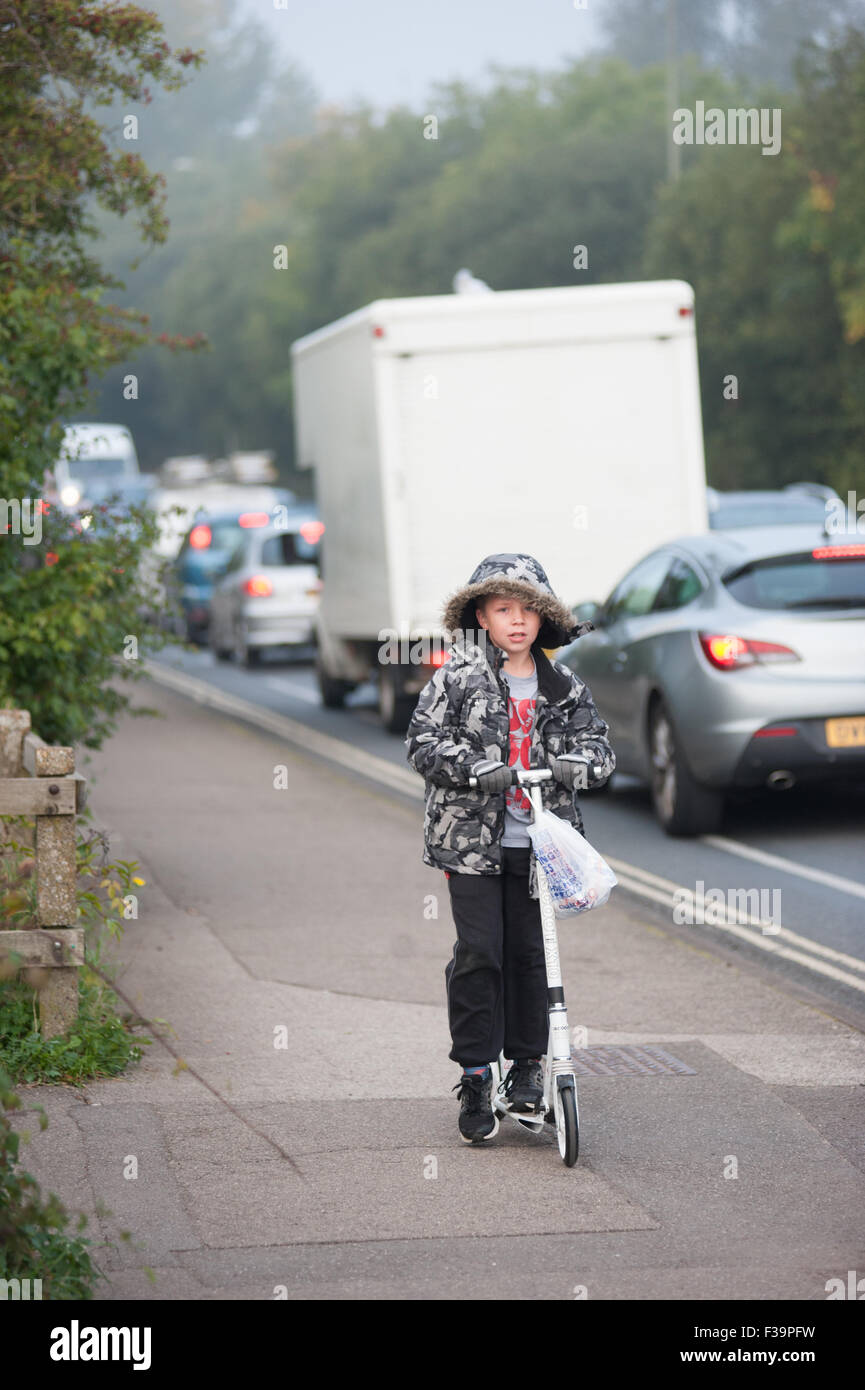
405 632 616 898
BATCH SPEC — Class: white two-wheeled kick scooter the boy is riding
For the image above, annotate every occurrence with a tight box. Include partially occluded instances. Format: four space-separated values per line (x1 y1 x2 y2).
469 767 599 1168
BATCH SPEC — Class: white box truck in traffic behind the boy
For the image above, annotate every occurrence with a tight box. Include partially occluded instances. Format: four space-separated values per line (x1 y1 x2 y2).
291 273 708 731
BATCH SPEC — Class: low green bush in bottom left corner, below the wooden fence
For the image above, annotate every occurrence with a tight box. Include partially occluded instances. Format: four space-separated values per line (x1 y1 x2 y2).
0 1065 104 1300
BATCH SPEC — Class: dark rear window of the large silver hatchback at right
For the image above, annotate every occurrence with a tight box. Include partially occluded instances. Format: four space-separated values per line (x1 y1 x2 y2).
723 546 865 609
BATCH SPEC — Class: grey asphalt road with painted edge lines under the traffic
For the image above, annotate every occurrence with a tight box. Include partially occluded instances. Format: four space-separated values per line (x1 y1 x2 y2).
152 646 865 1024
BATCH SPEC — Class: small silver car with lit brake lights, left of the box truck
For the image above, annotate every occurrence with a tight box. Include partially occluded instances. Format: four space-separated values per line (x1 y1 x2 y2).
209 514 324 666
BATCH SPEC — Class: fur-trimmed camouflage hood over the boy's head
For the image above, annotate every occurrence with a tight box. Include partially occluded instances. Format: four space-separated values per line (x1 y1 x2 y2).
442 553 594 649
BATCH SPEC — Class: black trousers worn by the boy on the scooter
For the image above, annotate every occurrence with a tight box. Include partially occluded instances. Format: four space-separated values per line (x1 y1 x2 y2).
445 845 549 1066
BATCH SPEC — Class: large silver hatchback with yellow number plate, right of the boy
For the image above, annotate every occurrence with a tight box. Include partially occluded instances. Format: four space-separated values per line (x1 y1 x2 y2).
558 525 865 835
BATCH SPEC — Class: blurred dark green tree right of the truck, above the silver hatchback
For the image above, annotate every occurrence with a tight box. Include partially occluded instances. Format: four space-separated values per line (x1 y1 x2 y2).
641 47 865 495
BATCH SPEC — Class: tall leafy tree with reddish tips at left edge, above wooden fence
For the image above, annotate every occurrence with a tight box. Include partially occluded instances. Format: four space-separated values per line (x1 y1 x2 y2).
0 0 202 746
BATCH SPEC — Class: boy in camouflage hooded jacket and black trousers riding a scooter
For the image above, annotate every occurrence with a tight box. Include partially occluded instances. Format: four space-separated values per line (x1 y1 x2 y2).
406 555 616 1144
